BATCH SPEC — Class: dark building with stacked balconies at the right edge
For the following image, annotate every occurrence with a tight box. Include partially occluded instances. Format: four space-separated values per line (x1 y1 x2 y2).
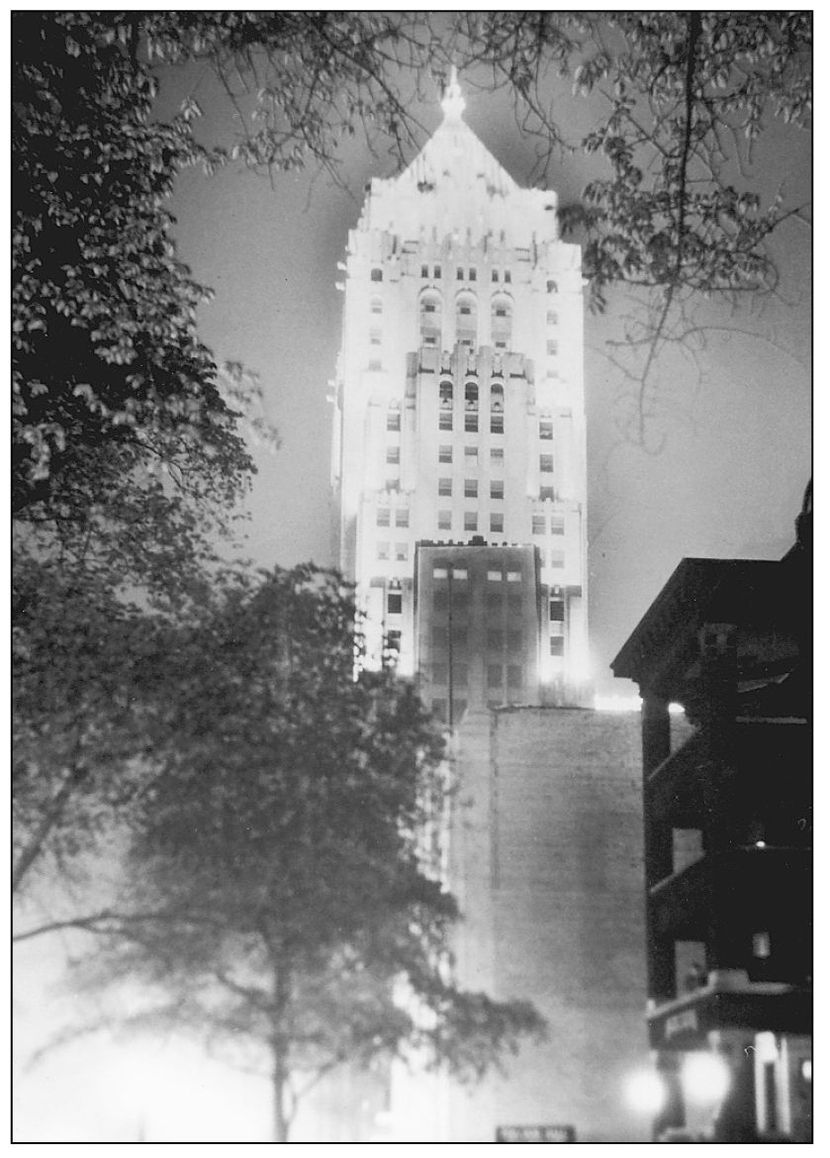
611 525 813 1143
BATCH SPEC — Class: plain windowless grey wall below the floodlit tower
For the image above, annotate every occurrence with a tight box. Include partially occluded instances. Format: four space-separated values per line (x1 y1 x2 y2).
449 708 648 1142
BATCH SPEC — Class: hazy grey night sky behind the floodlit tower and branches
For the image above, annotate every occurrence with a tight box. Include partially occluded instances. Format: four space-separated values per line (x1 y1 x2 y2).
166 58 811 691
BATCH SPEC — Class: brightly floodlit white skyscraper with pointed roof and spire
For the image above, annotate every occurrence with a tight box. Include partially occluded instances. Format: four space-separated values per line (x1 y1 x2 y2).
333 76 588 704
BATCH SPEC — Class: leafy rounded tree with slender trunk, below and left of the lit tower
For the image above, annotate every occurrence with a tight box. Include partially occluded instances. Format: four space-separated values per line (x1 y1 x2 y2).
48 567 542 1141
